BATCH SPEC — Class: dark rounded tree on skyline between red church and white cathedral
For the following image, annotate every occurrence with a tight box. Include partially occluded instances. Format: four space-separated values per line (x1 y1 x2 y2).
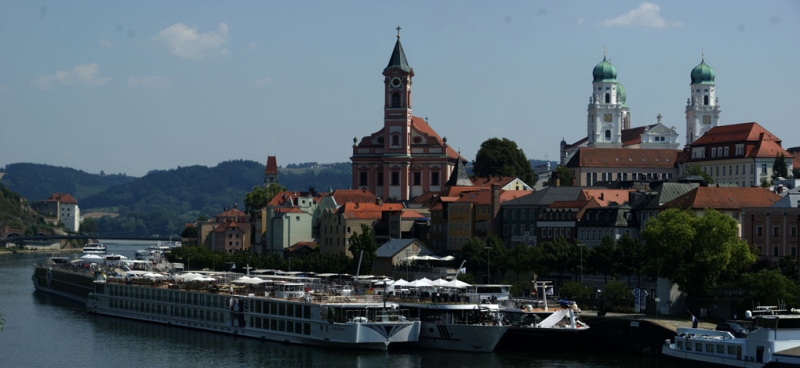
472 138 536 186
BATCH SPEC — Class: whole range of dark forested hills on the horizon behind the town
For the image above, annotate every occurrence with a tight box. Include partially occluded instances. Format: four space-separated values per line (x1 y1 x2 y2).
0 160 352 235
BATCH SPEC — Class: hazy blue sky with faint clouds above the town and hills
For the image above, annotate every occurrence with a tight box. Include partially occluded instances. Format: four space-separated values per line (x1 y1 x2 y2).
0 0 800 176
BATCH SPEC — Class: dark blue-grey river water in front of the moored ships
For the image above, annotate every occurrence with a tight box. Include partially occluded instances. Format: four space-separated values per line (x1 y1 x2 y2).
0 241 678 368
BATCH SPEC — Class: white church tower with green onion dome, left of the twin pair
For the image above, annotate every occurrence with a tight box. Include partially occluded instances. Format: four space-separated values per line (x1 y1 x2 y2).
586 56 631 148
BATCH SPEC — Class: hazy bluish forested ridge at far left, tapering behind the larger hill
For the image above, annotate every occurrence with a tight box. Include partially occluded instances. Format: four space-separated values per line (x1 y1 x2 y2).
0 163 136 202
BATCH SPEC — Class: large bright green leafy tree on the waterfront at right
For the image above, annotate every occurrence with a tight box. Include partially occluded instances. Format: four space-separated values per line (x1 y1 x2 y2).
642 208 756 295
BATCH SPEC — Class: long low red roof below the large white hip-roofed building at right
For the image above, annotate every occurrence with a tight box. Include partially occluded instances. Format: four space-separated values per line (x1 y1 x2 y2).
662 187 781 210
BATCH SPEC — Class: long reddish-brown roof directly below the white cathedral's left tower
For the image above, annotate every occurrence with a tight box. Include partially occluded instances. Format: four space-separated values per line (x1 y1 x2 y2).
567 147 681 168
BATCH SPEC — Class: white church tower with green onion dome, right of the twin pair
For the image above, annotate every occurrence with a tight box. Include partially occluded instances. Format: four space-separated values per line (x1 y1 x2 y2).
686 55 722 145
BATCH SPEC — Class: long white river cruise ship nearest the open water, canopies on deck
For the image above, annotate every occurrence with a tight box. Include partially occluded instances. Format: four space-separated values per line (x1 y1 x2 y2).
32 260 420 350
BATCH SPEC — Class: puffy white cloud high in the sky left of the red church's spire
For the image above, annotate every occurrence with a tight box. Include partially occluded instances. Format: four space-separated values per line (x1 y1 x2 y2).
153 23 228 59
